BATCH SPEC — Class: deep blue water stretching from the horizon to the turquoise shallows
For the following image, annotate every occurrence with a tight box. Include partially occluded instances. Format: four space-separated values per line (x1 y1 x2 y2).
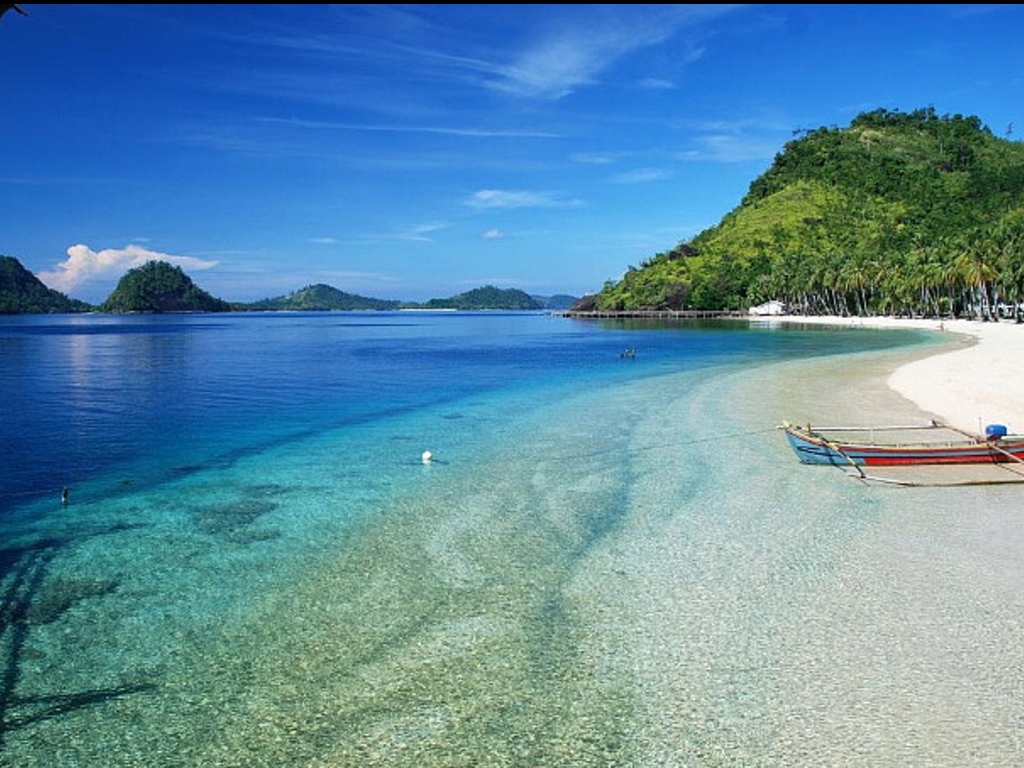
0 312 913 512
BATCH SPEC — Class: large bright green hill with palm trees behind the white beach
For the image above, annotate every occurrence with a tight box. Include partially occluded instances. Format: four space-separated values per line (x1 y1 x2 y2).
575 109 1024 317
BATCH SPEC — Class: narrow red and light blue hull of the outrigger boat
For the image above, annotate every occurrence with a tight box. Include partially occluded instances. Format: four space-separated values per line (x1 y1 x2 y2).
785 427 1024 466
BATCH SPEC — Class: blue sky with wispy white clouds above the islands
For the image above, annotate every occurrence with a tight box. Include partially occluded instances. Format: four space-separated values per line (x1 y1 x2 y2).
0 3 1024 302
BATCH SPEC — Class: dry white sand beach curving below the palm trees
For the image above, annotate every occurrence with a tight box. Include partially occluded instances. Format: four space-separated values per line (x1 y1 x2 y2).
771 315 1024 434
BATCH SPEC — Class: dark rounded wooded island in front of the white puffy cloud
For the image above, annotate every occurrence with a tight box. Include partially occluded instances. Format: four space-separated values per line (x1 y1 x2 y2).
99 261 233 312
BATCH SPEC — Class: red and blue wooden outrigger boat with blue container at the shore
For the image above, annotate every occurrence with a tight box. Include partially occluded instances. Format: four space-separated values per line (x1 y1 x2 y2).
780 421 1024 467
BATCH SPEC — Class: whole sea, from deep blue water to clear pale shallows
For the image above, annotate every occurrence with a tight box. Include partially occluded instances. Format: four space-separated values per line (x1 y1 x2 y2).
0 311 1024 768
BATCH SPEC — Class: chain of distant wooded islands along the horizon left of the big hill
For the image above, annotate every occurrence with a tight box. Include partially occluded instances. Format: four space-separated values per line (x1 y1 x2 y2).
0 256 579 314
